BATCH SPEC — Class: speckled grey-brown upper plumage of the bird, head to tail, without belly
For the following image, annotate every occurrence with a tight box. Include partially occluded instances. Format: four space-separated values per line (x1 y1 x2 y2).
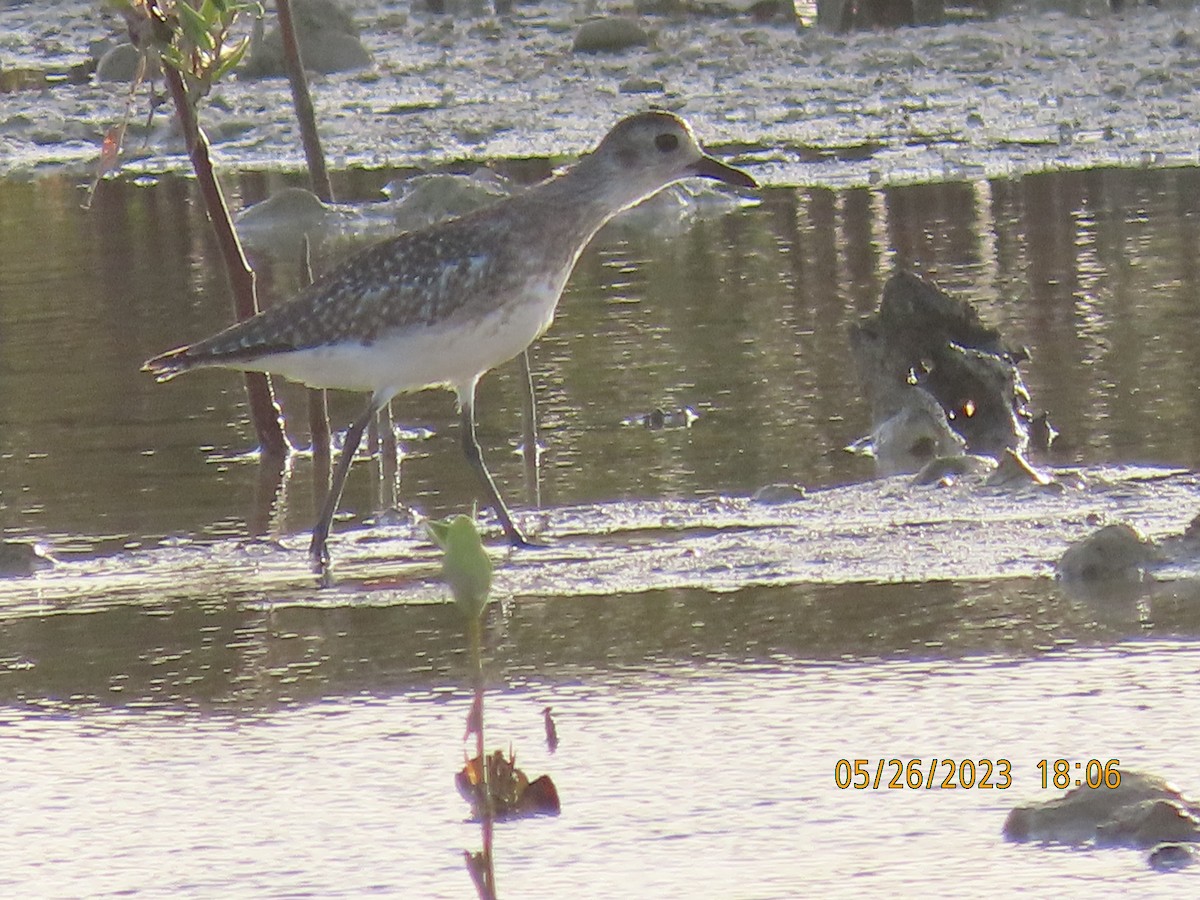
145 113 752 379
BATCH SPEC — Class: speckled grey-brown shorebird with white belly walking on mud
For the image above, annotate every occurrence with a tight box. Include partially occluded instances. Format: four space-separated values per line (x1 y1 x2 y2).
143 110 757 575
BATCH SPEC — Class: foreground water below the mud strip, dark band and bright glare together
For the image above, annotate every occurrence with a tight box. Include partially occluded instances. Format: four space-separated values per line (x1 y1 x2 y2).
0 582 1200 898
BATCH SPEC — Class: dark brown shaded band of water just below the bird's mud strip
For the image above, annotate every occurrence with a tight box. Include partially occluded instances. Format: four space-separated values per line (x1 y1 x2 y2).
9 582 1200 715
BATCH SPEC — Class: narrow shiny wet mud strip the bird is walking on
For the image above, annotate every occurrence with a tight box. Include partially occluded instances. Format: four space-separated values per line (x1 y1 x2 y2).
0 467 1196 614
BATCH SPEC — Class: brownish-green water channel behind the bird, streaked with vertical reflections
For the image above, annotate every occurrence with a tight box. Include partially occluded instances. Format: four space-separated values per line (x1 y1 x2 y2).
0 169 1200 552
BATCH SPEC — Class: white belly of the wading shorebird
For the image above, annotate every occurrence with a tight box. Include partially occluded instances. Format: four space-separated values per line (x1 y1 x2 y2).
240 290 558 397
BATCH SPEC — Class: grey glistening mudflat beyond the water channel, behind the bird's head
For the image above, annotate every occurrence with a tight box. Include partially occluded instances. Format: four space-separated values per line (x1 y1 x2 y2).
0 2 1200 186
